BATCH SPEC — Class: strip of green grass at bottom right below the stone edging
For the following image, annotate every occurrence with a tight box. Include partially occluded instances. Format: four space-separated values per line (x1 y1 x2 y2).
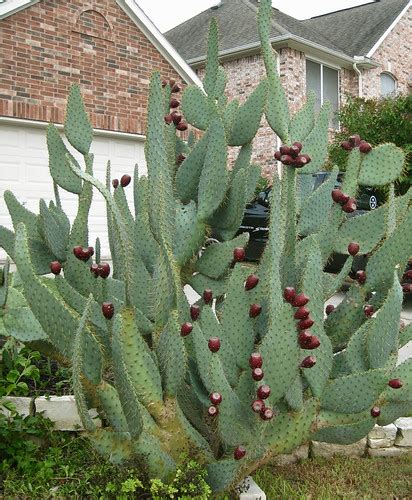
254 455 412 500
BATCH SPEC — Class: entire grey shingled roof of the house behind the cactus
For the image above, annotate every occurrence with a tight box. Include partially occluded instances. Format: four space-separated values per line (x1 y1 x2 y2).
165 0 410 63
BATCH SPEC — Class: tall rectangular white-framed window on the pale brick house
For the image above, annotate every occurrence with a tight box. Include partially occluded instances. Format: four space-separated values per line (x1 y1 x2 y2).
306 59 339 128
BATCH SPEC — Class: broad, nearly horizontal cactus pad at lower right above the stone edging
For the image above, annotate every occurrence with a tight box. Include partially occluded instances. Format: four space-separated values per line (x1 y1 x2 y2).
321 370 386 413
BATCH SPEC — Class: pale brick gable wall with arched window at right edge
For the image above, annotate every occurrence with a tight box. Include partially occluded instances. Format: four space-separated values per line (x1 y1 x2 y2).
363 8 412 97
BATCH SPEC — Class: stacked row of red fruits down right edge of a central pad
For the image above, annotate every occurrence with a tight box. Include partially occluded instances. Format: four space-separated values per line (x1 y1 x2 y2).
283 286 320 368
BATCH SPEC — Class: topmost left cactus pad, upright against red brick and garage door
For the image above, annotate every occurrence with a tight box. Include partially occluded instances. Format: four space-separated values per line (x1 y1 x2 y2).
64 85 93 155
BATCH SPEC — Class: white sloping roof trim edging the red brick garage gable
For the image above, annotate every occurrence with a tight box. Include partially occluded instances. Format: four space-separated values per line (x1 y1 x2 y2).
0 0 202 87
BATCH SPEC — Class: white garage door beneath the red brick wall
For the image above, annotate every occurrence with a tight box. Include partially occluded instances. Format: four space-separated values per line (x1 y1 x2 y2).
0 121 146 261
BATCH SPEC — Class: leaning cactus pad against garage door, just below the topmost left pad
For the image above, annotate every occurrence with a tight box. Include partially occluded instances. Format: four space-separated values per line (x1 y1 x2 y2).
47 124 82 194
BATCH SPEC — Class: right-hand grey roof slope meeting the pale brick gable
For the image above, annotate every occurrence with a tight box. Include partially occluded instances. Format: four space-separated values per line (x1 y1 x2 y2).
302 0 410 56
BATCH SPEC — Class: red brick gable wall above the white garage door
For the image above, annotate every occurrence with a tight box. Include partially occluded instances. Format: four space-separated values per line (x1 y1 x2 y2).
0 0 180 133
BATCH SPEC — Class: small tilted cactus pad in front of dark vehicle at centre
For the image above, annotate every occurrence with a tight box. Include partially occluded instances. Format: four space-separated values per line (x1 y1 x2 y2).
195 233 249 279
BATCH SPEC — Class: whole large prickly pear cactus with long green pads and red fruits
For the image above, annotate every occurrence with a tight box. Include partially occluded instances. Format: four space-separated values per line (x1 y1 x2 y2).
0 0 412 491
